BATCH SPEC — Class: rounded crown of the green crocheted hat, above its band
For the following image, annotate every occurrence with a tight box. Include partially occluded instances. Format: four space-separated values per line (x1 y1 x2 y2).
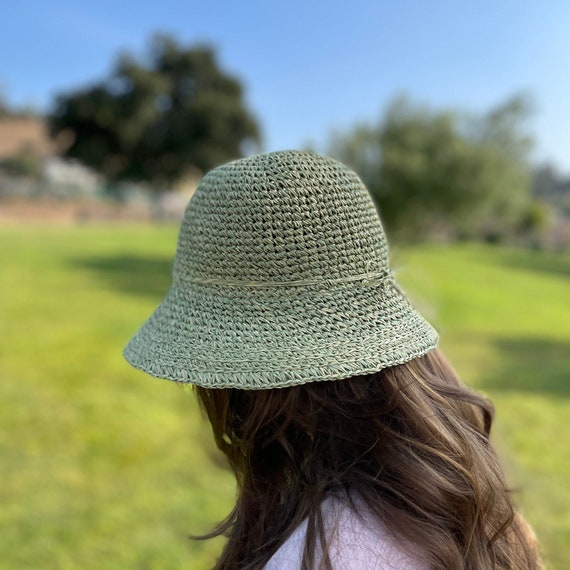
174 151 388 284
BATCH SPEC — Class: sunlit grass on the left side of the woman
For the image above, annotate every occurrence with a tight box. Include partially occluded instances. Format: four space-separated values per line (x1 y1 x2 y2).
0 228 234 570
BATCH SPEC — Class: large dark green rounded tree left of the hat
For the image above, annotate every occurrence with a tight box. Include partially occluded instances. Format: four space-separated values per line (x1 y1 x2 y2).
49 35 260 186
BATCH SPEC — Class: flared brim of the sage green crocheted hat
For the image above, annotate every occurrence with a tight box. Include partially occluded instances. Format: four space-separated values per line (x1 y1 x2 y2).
124 278 438 390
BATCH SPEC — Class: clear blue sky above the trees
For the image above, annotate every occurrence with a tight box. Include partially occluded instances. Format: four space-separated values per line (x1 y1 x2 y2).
0 0 570 173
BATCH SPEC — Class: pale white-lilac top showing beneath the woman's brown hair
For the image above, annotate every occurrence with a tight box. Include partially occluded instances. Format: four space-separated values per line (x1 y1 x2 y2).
265 497 429 570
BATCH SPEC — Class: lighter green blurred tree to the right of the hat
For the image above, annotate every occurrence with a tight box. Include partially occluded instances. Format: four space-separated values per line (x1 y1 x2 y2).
331 92 530 240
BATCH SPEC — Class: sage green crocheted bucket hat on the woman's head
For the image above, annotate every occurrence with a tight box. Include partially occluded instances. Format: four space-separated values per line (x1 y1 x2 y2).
124 151 438 389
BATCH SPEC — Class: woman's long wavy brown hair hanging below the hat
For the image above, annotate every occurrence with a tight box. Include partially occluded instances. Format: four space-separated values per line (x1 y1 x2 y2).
192 350 542 570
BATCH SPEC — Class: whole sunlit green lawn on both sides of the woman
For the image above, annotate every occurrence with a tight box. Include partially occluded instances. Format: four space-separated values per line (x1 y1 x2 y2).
0 226 570 570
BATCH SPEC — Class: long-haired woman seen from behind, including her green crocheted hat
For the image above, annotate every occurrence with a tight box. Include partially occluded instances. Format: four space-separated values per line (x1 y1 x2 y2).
125 151 542 570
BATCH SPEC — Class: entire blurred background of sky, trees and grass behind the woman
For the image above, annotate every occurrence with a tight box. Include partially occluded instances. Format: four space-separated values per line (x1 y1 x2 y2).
0 0 570 570
